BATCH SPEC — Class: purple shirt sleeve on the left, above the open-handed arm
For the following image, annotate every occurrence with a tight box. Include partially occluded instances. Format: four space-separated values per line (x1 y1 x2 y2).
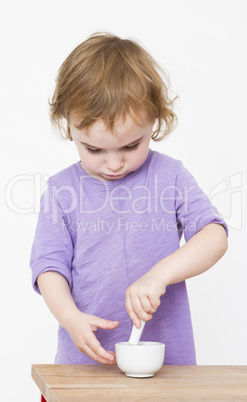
30 187 73 294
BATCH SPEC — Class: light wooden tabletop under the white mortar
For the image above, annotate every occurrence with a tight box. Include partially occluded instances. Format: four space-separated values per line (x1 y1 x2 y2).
32 364 247 402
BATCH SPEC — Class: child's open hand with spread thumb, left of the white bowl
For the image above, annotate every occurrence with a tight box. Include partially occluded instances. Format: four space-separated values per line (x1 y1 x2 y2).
66 310 119 364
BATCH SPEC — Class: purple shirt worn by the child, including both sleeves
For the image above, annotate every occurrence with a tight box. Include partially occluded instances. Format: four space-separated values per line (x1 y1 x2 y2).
30 150 227 364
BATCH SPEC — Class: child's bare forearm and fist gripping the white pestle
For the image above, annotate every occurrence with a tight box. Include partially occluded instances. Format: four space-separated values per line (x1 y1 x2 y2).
126 223 227 327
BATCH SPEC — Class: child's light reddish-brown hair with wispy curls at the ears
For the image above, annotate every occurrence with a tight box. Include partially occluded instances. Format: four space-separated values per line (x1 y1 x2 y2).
49 33 177 141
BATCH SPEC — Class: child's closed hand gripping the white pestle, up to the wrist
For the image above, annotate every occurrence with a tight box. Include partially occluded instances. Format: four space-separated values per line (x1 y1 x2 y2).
125 273 166 328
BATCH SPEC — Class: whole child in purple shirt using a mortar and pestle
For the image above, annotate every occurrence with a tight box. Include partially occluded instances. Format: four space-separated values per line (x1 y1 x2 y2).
31 34 227 365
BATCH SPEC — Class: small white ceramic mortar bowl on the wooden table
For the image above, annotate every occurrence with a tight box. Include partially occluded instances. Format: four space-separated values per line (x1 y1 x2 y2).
115 342 165 377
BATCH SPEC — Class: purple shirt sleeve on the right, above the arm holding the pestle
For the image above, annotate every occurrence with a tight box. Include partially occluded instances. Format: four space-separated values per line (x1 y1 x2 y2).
175 164 228 241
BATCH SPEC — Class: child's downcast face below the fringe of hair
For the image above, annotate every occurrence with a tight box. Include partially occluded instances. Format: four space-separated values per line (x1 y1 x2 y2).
69 111 154 180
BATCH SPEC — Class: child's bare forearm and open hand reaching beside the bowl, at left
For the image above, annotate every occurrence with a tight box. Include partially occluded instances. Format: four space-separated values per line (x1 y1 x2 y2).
37 271 119 364
